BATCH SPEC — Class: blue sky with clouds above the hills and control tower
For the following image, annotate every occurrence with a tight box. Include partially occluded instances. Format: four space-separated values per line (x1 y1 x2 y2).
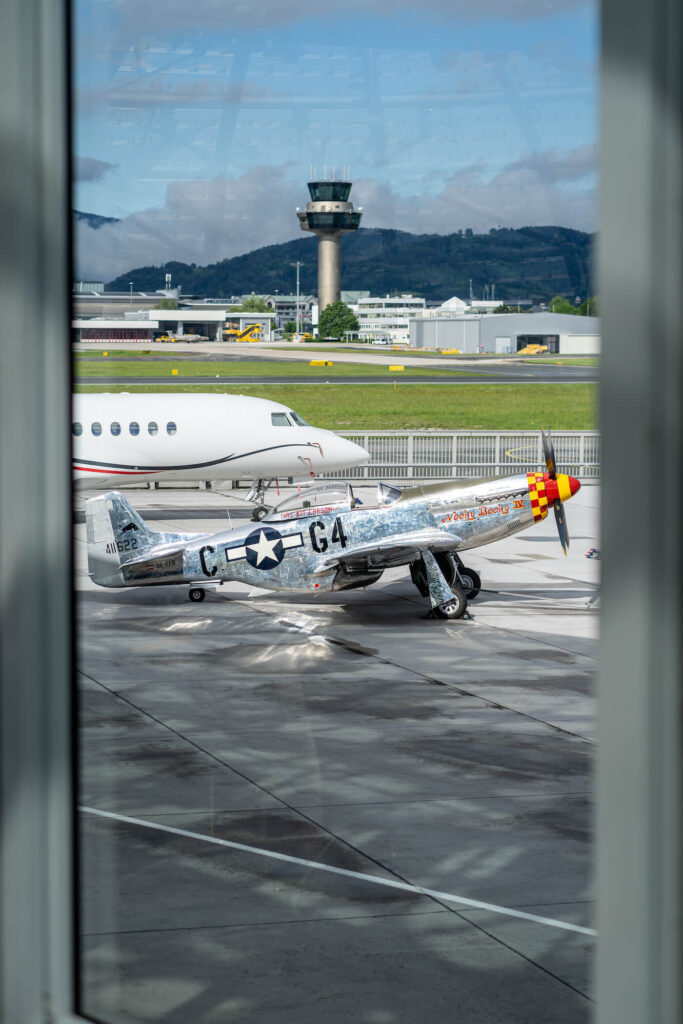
73 0 598 282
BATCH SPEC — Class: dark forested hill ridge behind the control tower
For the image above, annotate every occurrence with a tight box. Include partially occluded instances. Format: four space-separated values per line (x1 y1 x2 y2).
108 227 595 301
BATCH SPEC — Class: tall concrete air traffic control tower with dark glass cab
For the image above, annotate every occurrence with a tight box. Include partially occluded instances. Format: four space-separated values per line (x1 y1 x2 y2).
297 181 362 312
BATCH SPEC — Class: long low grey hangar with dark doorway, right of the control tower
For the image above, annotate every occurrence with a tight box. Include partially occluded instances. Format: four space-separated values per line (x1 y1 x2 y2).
410 312 600 355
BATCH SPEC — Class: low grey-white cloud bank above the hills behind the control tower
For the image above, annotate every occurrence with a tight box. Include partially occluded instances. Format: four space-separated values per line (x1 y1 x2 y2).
76 146 596 281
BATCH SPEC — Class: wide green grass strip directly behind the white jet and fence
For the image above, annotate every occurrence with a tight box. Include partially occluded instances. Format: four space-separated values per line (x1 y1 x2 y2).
76 382 597 431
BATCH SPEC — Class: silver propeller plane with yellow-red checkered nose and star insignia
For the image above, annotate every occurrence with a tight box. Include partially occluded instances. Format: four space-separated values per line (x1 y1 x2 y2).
85 433 581 618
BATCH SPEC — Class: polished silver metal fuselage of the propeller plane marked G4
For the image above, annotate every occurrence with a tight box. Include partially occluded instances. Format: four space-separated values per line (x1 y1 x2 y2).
91 474 535 592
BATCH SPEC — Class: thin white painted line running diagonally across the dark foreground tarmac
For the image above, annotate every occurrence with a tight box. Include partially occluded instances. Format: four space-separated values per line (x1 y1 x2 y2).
79 807 597 936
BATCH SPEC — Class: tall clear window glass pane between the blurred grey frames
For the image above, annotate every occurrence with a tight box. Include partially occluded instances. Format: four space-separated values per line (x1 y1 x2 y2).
74 0 599 1024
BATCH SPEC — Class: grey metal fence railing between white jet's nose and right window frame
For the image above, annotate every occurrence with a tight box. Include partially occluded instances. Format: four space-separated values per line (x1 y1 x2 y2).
329 430 600 483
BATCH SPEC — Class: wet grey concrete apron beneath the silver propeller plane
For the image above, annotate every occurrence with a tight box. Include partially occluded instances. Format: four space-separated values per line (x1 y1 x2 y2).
75 485 599 1024
